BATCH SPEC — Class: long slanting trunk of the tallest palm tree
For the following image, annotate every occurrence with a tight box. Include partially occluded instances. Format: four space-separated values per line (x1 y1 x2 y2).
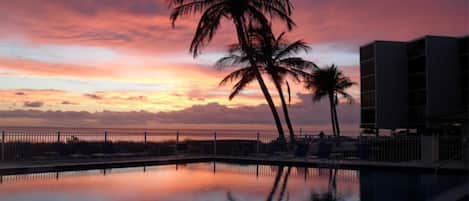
234 18 286 148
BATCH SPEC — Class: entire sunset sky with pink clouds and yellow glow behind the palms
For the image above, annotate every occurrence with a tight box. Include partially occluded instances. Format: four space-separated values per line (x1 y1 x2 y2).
0 0 469 131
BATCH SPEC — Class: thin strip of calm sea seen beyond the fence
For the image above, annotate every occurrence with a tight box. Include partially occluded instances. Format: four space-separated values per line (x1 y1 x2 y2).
0 127 282 142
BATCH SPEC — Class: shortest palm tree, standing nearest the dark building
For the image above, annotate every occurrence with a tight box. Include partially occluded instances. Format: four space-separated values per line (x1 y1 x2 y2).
305 64 356 136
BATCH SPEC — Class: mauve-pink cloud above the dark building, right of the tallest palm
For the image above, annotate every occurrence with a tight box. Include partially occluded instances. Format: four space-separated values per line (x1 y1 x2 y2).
293 0 469 44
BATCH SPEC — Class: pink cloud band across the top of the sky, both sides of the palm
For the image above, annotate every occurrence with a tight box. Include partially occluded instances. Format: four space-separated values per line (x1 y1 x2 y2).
0 0 468 53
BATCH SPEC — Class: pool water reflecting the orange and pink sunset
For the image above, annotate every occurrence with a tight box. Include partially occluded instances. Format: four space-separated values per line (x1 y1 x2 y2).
0 163 468 201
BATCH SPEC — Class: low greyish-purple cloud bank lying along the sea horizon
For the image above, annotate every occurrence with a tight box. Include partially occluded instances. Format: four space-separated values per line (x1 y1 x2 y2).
0 94 359 134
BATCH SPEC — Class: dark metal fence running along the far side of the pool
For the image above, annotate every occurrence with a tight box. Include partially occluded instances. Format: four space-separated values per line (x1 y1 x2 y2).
0 131 463 162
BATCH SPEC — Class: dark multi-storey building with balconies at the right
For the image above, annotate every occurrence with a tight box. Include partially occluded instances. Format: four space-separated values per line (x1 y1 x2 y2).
360 36 469 133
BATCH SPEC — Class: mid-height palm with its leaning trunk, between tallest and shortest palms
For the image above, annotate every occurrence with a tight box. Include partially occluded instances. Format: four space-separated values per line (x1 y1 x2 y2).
216 26 317 144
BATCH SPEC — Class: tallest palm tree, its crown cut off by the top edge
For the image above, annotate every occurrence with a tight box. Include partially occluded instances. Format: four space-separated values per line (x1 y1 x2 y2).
169 0 294 148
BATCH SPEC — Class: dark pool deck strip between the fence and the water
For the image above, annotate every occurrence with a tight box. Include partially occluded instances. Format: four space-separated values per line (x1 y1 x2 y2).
0 155 469 175
